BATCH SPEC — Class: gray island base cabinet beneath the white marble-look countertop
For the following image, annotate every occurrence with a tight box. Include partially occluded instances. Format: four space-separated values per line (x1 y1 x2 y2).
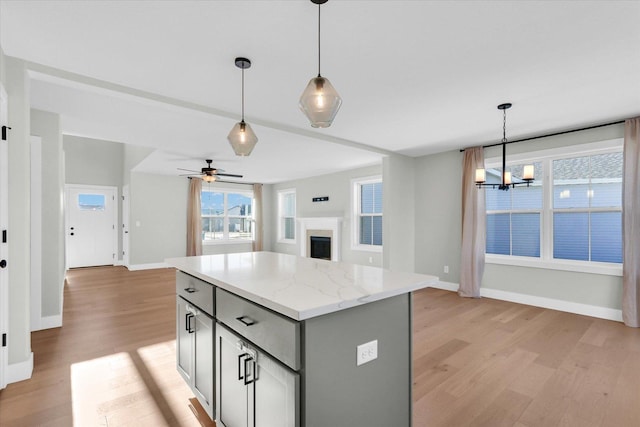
176 272 412 427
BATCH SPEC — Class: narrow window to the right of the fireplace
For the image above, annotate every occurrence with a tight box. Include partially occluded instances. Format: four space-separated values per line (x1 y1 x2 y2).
352 177 382 251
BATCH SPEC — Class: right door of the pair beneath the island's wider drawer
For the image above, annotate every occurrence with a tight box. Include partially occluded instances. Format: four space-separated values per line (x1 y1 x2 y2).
253 353 300 427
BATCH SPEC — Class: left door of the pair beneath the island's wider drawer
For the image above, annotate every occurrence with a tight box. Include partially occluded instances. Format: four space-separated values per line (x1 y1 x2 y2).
216 324 249 427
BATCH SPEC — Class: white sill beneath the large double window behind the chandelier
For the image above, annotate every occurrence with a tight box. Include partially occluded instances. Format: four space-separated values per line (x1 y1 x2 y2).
485 254 622 276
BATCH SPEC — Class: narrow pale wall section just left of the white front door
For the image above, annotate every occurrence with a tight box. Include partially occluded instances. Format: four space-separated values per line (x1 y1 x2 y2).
31 110 65 329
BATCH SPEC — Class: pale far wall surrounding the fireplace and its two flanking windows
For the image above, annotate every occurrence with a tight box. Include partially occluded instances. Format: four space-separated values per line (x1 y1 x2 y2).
265 165 386 266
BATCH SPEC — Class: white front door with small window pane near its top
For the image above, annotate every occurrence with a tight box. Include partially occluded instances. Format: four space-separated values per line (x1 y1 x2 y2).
66 185 118 268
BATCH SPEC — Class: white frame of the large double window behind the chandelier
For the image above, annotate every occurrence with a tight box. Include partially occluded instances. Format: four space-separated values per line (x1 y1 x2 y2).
481 138 623 276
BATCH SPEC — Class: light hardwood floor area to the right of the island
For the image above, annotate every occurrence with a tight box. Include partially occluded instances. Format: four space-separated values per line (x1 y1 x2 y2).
413 289 640 427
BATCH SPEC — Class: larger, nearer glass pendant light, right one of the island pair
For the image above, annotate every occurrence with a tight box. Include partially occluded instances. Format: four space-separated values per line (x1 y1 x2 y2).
299 0 342 128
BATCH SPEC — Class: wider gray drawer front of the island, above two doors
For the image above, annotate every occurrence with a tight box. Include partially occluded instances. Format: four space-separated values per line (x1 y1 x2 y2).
216 288 300 371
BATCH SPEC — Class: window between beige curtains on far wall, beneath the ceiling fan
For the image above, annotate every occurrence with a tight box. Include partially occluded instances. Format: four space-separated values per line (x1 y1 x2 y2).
201 190 253 243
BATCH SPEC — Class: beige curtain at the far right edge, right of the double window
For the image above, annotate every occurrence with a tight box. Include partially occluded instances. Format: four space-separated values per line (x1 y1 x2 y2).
622 117 640 328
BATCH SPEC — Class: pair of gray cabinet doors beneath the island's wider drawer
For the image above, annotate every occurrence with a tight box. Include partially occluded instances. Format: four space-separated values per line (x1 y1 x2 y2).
216 324 299 427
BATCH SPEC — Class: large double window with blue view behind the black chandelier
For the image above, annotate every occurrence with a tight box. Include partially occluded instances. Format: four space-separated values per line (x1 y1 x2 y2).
482 140 622 275
